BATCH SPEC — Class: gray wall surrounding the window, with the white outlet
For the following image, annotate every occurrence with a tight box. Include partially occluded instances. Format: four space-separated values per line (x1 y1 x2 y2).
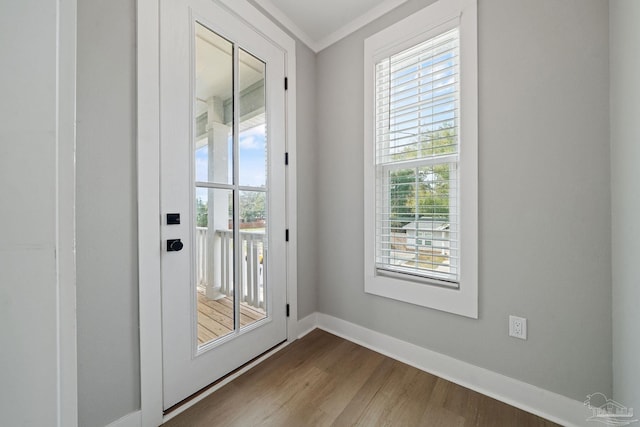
316 0 612 400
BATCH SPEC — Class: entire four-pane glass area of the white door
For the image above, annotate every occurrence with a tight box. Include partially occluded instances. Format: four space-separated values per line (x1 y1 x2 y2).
193 23 268 347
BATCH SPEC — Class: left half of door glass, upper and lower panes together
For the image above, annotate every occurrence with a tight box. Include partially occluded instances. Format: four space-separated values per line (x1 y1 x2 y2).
194 22 236 346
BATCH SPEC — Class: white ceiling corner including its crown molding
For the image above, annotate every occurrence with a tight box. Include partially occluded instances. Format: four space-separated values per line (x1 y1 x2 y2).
254 0 407 52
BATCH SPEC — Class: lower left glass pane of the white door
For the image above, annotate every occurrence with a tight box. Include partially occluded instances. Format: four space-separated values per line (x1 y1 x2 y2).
195 188 235 345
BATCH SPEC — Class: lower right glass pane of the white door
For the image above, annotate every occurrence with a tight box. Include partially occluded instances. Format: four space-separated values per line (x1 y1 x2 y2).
240 191 267 326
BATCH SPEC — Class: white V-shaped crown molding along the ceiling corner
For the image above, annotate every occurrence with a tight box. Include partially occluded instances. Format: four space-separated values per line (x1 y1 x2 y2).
255 0 407 53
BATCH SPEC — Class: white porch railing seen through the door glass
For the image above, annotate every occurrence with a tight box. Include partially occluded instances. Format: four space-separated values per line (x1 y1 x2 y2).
196 227 266 309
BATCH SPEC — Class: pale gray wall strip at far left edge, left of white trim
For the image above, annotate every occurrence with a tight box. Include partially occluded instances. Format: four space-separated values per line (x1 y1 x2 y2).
0 0 63 427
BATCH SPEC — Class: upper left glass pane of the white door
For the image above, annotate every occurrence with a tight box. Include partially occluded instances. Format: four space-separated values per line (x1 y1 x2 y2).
194 23 233 184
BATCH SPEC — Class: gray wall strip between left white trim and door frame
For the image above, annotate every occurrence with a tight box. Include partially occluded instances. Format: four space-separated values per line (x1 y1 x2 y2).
77 0 140 427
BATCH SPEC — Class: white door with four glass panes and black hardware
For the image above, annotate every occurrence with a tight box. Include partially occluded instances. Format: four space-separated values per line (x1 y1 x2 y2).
160 0 287 410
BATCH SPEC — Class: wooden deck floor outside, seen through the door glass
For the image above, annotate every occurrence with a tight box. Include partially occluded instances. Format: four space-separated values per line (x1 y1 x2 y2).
198 292 266 344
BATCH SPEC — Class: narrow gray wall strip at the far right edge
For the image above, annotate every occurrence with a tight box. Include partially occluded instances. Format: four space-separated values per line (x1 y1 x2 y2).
609 0 640 412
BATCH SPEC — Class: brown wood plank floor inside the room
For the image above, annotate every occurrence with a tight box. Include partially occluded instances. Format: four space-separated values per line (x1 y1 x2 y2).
164 329 556 427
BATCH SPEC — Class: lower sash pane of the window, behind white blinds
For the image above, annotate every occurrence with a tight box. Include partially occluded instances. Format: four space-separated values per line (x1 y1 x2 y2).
376 163 458 281
